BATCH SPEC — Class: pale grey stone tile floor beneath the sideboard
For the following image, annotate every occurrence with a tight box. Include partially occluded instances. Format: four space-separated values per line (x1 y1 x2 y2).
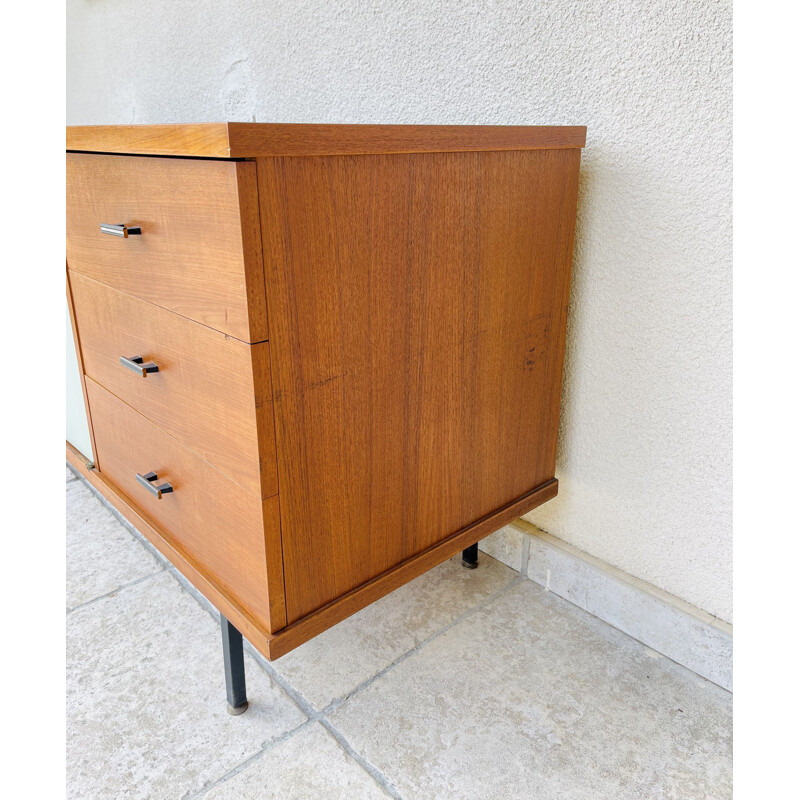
66 469 732 800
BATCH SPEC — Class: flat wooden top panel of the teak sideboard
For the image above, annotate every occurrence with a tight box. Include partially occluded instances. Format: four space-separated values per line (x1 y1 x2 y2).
67 122 586 158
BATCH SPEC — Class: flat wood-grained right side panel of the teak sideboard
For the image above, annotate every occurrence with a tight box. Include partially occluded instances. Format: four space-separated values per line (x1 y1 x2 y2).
258 149 580 624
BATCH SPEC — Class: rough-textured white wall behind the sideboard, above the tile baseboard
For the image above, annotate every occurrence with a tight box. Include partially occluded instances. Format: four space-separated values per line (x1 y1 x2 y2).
67 0 732 620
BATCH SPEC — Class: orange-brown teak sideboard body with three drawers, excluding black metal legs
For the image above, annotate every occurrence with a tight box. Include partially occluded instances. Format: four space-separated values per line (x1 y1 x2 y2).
67 123 586 712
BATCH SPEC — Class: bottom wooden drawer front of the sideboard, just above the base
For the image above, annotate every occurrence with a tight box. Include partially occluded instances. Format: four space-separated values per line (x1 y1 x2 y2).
86 377 286 631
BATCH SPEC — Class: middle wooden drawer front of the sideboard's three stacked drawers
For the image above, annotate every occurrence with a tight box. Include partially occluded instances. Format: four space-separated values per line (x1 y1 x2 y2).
69 270 278 497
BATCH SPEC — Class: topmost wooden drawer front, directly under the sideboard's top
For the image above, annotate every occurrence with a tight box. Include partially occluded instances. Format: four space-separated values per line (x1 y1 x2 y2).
67 153 267 342
